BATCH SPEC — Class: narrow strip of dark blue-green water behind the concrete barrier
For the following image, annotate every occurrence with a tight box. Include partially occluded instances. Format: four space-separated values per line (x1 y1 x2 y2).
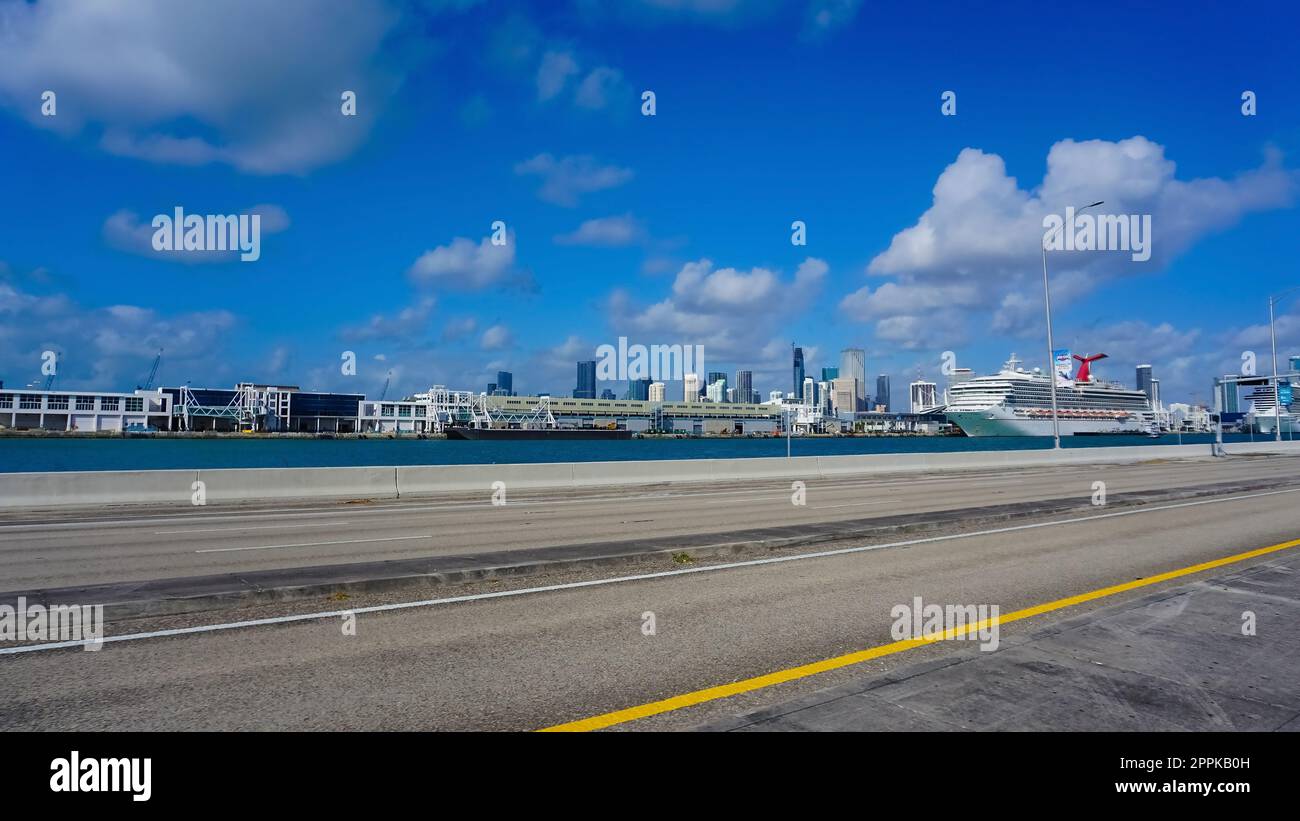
0 434 1251 473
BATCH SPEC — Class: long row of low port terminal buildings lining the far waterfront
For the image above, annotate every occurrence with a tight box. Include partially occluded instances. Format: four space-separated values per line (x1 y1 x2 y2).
0 382 943 436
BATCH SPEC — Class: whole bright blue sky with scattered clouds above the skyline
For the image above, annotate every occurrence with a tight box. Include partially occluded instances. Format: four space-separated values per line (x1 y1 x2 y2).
0 0 1300 400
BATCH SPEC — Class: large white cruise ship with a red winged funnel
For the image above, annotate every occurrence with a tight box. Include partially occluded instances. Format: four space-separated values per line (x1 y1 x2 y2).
936 353 1154 436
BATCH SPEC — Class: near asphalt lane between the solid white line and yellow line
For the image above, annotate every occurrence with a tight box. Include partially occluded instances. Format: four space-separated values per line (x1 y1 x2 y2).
0 475 1300 730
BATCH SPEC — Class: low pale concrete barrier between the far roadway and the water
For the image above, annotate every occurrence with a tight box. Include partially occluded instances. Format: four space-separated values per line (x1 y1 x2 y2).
0 442 1300 509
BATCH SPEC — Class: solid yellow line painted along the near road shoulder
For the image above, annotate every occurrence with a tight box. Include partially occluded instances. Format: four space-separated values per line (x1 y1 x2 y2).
540 539 1300 733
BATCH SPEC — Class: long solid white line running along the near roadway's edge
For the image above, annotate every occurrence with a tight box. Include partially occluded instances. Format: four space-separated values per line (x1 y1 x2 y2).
0 487 1300 656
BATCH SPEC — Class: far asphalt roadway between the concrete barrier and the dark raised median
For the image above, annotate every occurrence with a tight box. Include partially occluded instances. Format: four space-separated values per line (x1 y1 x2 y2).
0 456 1300 592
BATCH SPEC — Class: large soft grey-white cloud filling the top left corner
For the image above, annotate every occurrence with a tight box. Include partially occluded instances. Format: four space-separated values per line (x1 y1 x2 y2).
0 0 402 174
